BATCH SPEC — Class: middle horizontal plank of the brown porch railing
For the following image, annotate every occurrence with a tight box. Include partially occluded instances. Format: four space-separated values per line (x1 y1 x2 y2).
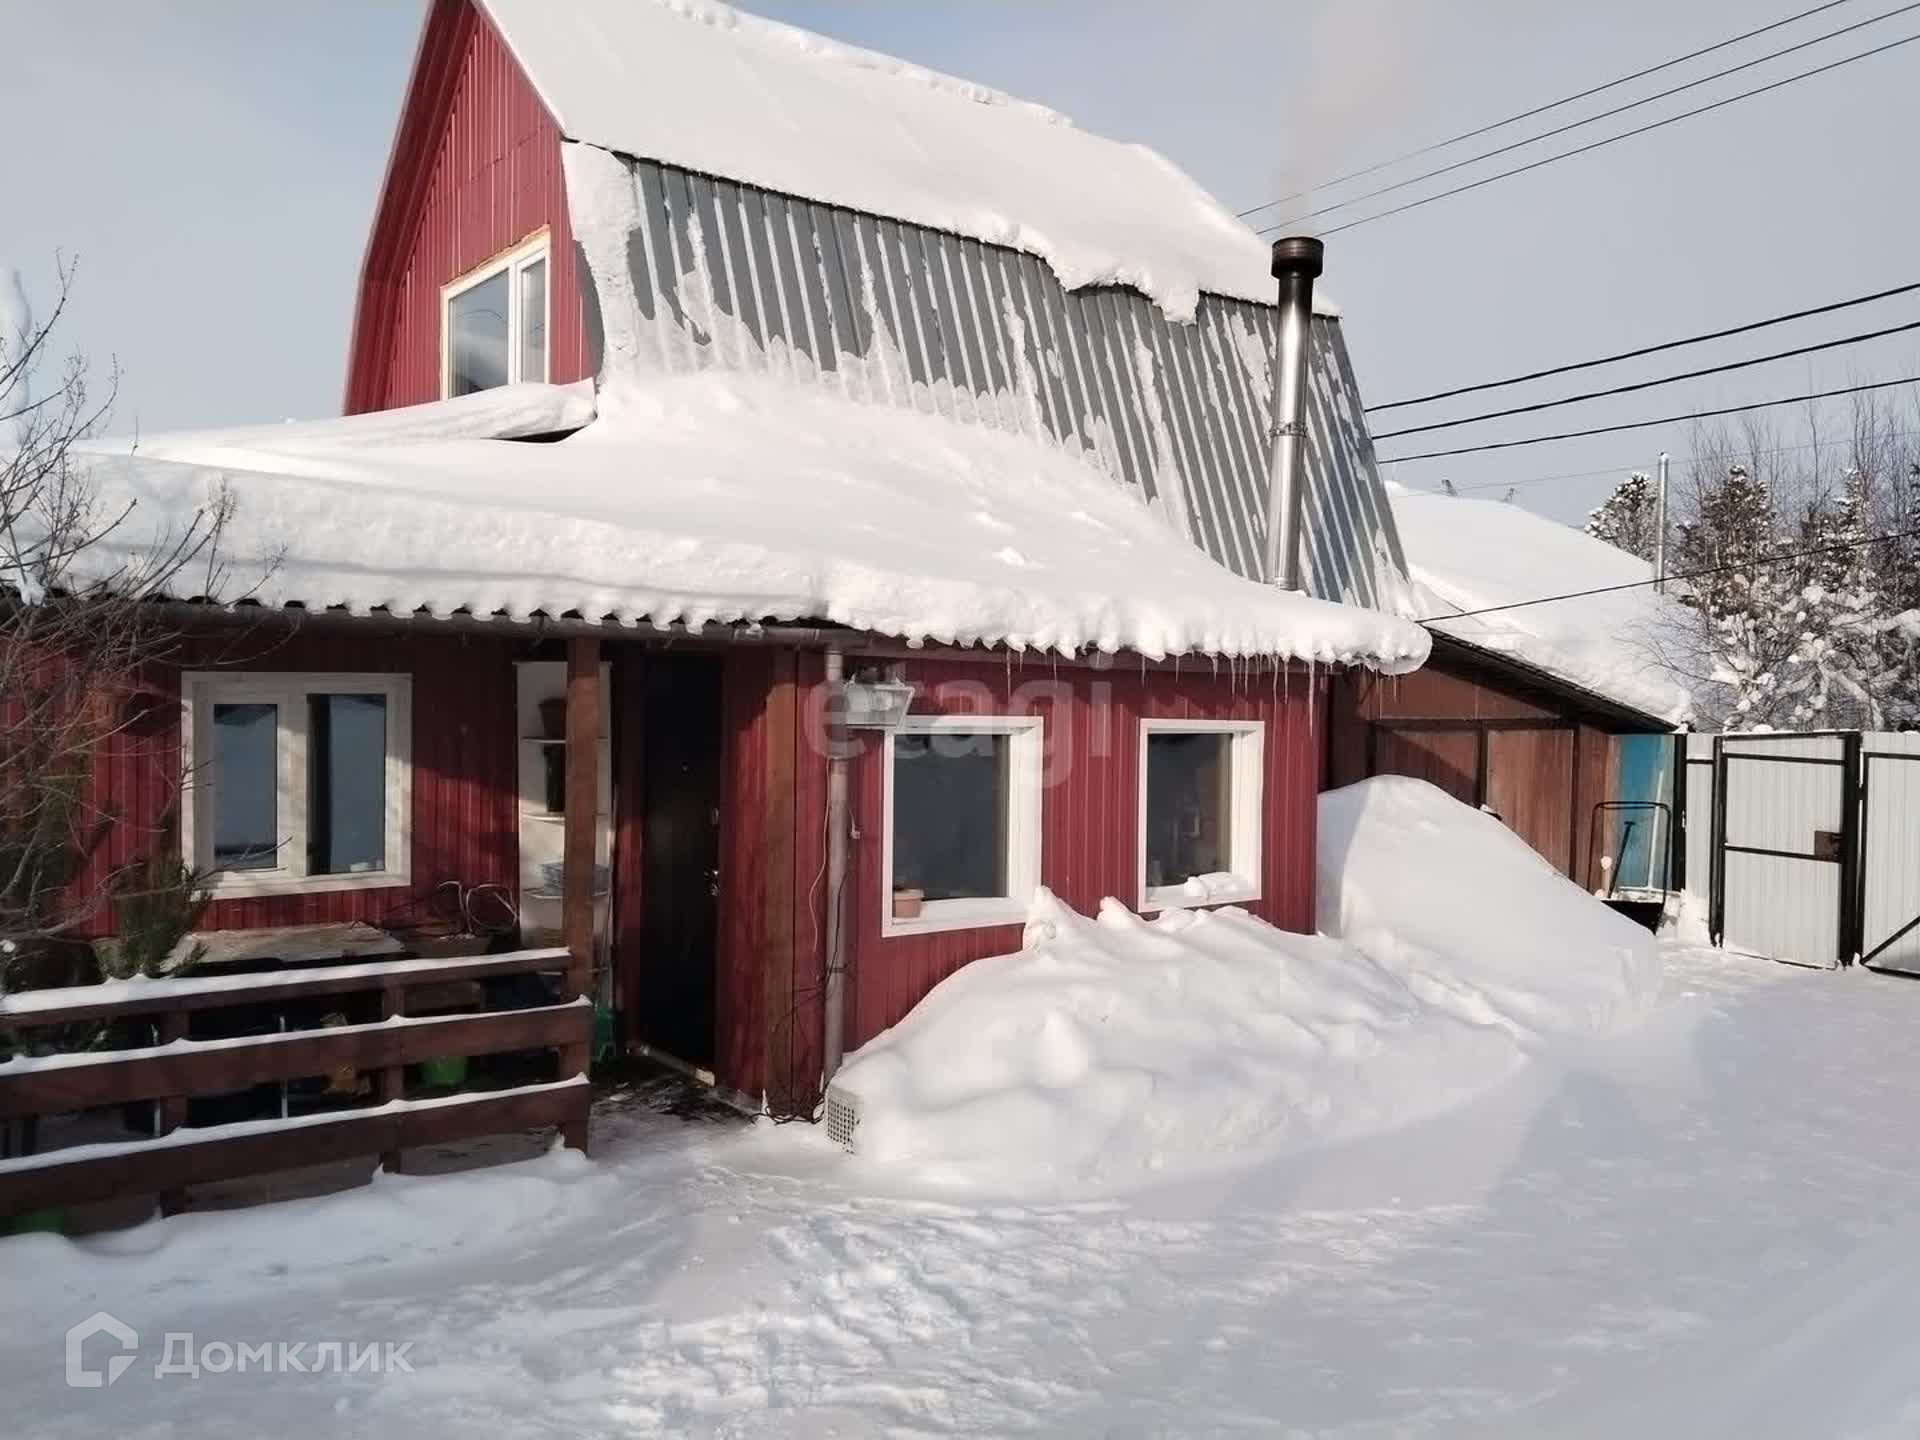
0 1004 593 1116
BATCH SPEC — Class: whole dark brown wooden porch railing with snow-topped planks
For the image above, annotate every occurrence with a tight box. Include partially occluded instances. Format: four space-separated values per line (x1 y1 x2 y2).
0 948 593 1217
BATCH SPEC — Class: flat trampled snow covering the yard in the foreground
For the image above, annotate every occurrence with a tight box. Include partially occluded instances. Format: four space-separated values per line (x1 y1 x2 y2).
0 948 1920 1440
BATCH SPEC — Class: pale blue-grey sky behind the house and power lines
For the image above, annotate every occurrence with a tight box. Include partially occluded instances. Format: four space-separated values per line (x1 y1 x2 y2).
0 0 1920 518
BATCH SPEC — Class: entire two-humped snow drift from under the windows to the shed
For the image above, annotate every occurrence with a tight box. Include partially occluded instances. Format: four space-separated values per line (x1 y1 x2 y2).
835 780 1659 1192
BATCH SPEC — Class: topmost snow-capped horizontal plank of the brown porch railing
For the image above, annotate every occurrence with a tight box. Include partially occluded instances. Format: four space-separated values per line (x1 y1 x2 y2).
0 948 568 1029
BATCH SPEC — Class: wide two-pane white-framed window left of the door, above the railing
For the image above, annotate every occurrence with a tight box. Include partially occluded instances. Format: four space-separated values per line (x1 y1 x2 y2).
180 674 413 895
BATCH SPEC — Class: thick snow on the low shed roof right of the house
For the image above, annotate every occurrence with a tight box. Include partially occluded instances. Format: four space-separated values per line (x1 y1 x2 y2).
1388 484 1693 724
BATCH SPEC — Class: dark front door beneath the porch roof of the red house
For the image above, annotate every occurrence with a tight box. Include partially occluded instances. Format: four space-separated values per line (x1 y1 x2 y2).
637 657 720 1066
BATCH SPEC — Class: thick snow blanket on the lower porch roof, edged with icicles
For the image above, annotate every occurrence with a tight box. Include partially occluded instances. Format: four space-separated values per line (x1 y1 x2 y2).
71 380 1428 672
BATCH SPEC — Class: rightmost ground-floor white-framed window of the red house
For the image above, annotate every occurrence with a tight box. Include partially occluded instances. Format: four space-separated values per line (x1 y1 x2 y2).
1140 720 1263 910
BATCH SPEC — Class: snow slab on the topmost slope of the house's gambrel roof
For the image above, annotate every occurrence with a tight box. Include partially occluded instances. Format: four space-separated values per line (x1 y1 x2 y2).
482 0 1305 319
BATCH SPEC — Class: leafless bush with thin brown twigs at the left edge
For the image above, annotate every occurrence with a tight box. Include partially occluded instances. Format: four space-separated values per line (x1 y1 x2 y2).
0 267 232 991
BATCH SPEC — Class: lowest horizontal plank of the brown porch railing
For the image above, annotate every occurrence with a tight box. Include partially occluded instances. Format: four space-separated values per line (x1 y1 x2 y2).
0 1081 593 1215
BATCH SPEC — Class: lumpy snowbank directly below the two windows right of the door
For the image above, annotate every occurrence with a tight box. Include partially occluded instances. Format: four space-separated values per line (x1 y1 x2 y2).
835 893 1521 1194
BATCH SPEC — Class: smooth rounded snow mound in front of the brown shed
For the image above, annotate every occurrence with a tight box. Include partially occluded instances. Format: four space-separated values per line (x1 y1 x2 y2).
1317 776 1661 1044
